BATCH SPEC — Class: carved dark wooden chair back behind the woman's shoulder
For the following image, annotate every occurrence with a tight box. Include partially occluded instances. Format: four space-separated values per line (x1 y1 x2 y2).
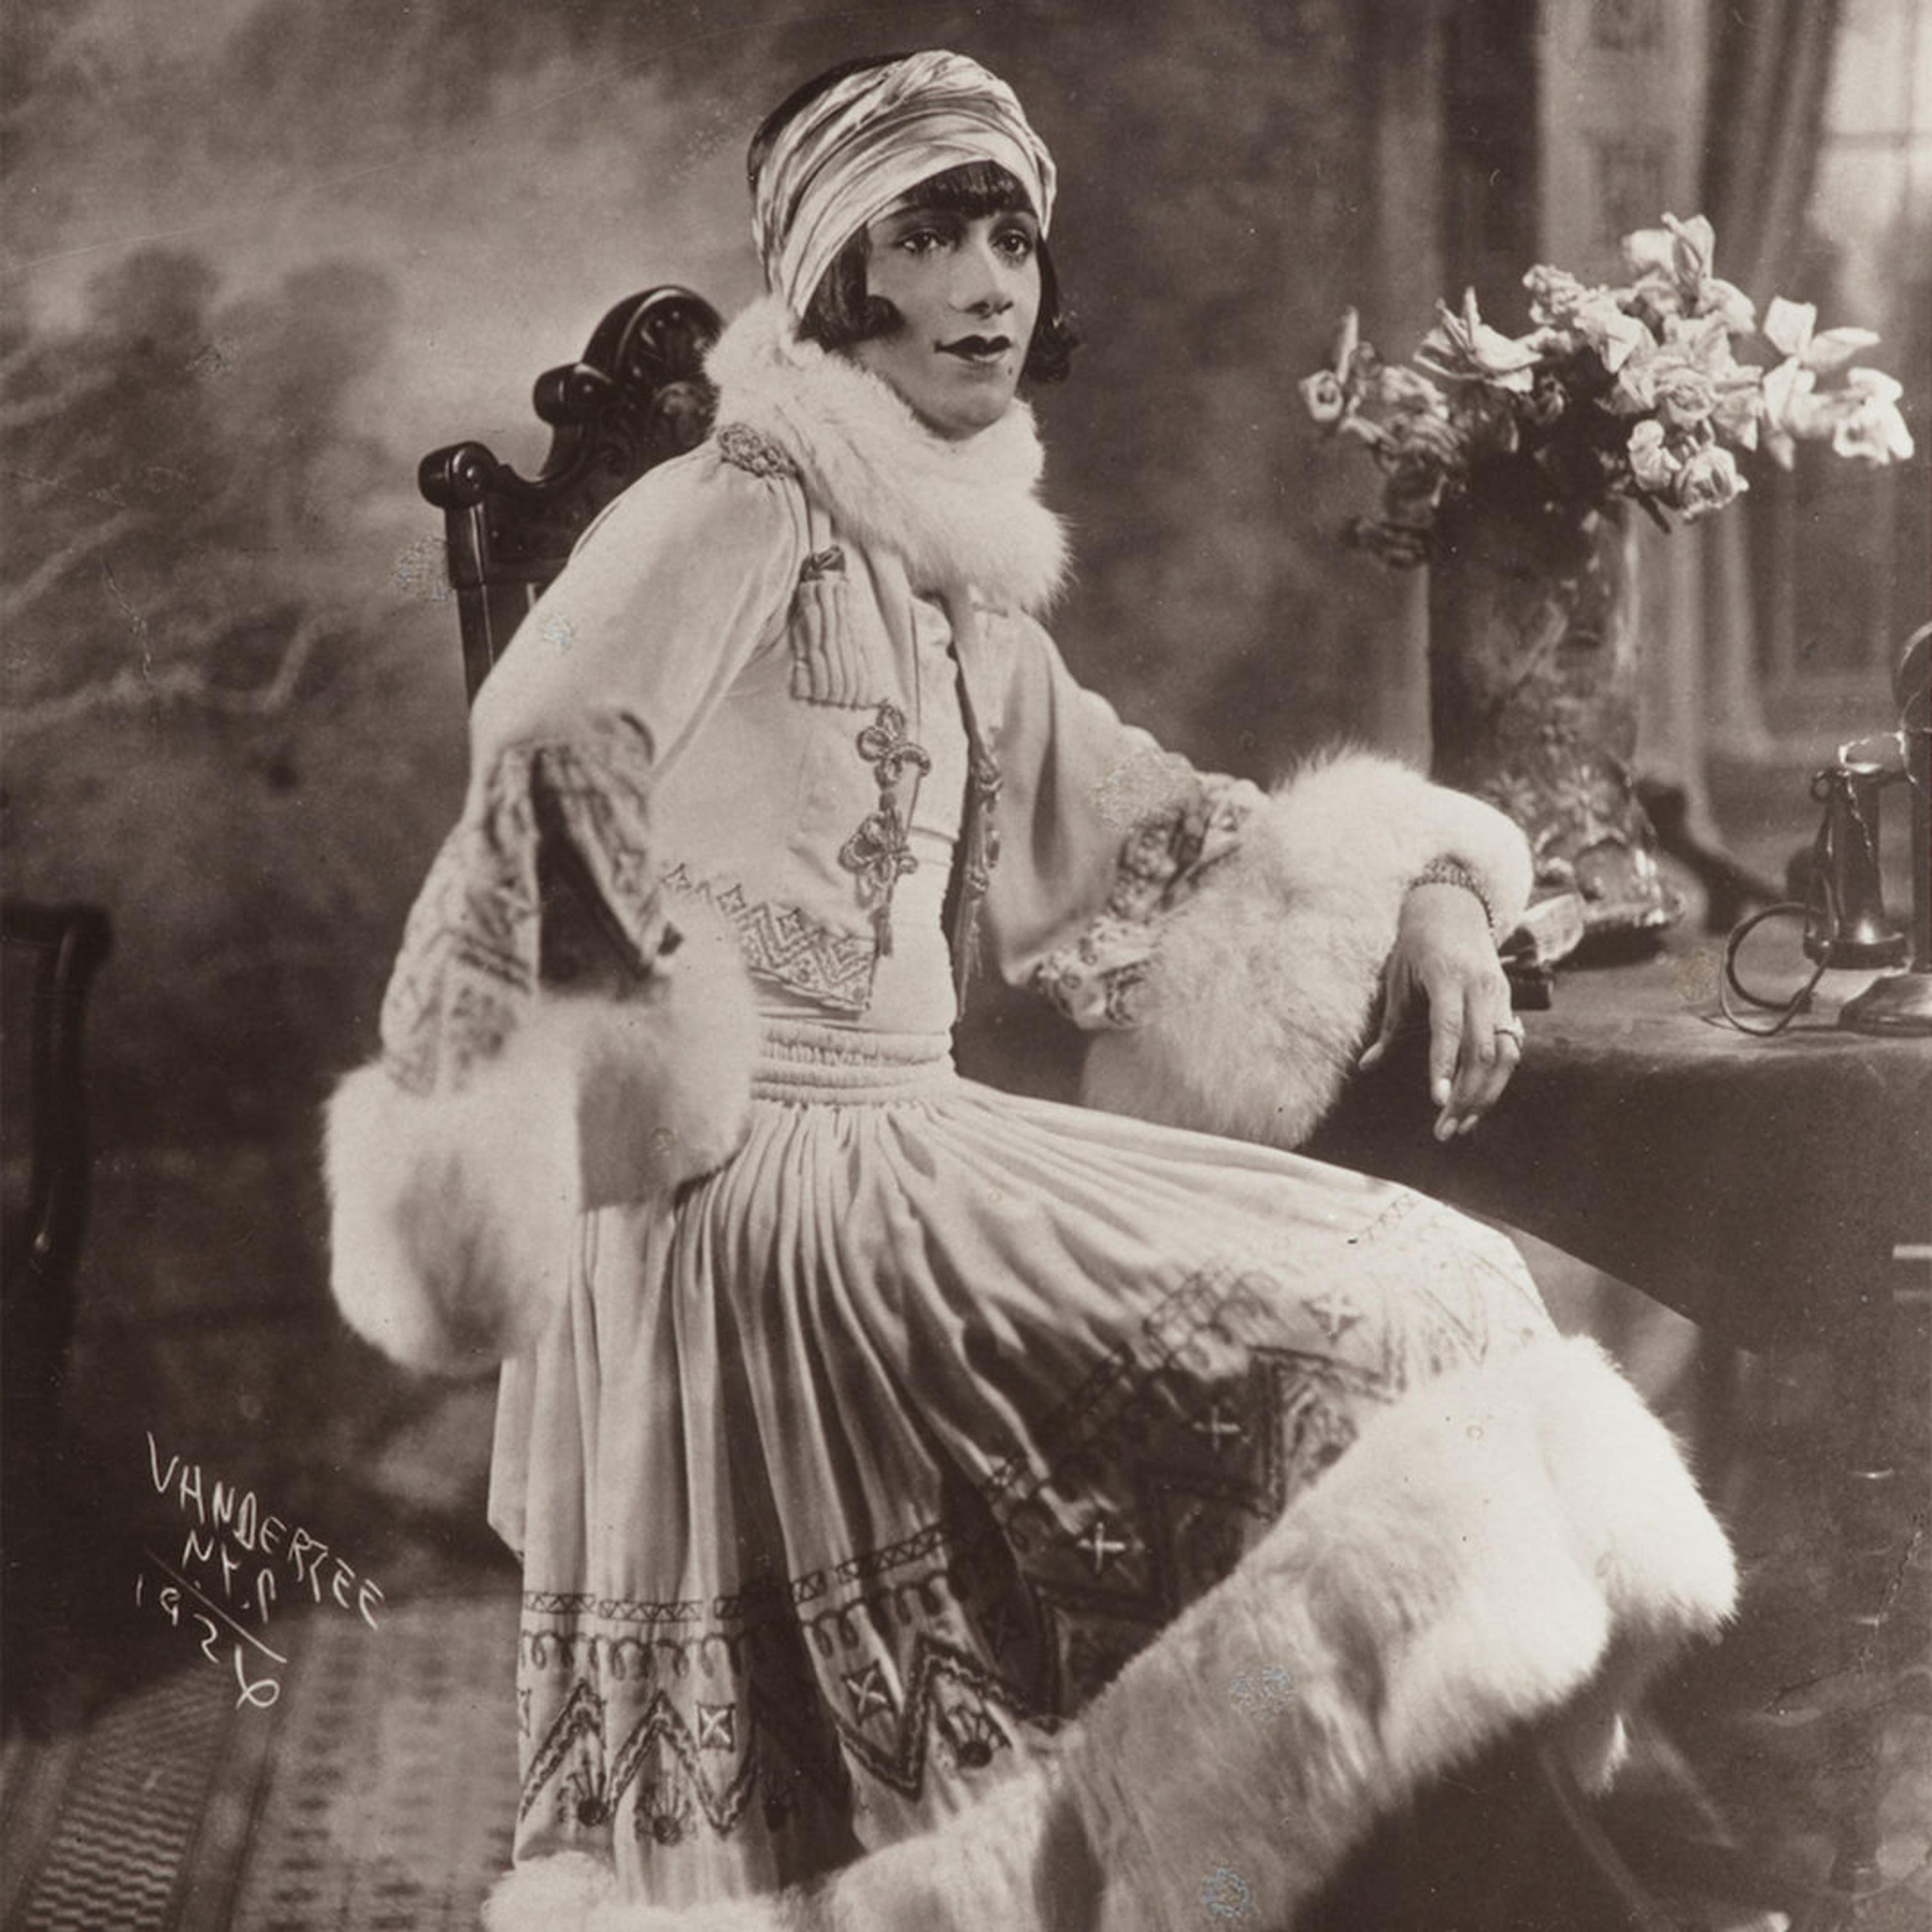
417 288 720 699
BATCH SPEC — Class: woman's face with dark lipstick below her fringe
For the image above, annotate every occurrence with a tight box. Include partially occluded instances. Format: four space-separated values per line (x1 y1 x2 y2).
848 203 1039 439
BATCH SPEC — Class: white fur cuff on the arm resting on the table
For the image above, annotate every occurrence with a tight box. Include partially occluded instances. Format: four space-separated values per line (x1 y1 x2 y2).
1082 752 1530 1148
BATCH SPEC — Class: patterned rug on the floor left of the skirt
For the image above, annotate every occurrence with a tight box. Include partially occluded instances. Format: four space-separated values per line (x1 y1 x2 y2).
0 1594 516 1932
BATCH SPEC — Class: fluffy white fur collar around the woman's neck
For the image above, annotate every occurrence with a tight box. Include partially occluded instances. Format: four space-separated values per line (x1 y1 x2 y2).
709 296 1067 610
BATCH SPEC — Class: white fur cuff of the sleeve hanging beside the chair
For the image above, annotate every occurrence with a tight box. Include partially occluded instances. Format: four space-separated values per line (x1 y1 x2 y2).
325 906 757 1374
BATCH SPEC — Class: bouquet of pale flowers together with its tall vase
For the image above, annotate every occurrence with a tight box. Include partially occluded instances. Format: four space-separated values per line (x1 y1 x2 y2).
1300 214 1913 950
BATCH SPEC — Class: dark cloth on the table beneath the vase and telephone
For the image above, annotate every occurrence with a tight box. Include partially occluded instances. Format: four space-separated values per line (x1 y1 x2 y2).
1308 950 1932 1346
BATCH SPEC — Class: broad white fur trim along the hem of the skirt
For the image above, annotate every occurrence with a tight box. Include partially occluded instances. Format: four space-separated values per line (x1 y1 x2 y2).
485 1339 1737 1932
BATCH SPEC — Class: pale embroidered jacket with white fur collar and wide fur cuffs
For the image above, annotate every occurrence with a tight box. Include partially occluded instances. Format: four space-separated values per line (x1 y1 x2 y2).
327 301 1530 1372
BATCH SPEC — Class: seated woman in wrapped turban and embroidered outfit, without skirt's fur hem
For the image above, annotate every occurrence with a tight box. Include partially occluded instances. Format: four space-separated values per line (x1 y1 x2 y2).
316 52 1692 1903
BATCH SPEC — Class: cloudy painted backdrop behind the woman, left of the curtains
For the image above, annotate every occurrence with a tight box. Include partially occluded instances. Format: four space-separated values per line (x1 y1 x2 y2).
0 0 1453 1511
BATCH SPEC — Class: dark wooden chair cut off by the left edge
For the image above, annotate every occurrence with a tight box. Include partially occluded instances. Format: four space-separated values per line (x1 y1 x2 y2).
0 902 112 1729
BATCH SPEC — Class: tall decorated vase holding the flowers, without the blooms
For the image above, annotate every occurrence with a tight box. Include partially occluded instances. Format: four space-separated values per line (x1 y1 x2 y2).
1430 499 1677 954
